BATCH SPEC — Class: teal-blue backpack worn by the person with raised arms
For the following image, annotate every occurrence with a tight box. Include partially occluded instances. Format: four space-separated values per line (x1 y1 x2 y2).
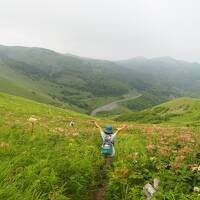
101 134 113 156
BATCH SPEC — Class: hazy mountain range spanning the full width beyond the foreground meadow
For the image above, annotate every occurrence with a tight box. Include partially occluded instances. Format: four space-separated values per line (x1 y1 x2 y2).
0 45 200 113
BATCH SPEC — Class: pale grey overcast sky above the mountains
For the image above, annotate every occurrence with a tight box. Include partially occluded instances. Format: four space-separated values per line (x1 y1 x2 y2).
0 0 200 61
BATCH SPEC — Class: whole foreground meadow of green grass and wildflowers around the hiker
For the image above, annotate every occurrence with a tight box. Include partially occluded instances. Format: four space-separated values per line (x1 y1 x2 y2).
0 93 200 200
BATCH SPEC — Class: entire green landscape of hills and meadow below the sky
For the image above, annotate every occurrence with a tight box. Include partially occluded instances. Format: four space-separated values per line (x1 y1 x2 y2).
0 46 200 200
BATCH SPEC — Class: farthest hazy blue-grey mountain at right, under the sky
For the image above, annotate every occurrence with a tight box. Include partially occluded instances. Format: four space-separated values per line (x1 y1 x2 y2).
117 57 200 96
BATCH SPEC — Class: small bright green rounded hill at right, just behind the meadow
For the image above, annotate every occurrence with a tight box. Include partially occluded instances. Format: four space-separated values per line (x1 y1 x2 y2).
116 97 200 126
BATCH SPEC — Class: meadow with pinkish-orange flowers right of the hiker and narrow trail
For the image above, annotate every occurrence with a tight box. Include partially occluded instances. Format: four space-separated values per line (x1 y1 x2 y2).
106 126 200 200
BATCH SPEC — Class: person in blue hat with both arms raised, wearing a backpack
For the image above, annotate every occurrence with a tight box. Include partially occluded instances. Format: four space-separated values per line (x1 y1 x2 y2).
94 121 127 158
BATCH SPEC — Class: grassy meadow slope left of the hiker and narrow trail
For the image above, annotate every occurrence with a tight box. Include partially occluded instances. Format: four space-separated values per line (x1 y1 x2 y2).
0 94 101 199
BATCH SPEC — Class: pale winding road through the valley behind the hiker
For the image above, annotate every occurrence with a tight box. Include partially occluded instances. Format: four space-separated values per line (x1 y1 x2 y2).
90 95 141 116
